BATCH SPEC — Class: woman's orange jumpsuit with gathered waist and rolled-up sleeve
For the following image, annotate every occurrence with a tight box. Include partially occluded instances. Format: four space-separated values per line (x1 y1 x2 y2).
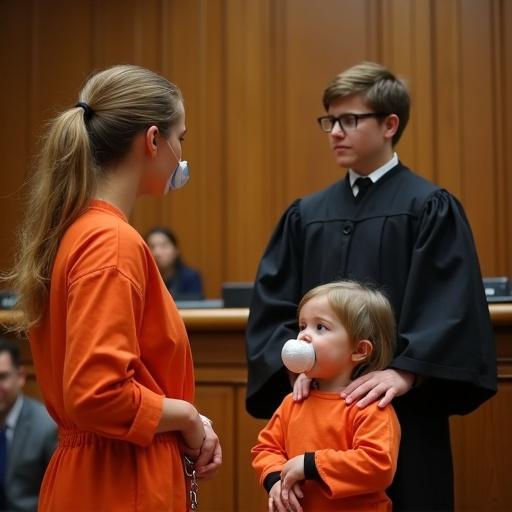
29 200 194 512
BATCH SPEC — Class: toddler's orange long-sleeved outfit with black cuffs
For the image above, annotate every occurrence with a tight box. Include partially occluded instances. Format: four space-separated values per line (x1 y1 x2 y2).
251 390 400 512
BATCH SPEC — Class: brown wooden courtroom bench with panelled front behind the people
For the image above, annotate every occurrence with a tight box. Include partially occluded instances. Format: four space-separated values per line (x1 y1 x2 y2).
0 304 512 512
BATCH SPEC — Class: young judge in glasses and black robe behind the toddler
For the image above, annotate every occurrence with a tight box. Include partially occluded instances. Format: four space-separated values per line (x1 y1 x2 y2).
246 63 496 511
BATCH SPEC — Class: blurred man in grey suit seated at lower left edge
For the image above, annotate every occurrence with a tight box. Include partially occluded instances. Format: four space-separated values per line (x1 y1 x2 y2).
0 339 57 511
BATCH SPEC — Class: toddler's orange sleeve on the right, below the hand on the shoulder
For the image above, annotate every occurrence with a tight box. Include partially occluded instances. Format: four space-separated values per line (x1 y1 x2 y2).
315 403 400 499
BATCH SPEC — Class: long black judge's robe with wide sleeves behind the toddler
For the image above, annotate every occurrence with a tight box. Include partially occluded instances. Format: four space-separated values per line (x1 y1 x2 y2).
246 163 496 511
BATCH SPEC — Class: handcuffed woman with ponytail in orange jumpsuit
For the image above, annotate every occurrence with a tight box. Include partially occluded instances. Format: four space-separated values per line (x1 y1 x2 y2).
6 66 221 512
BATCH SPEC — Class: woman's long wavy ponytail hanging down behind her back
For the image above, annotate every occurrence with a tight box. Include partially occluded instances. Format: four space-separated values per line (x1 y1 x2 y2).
6 107 95 331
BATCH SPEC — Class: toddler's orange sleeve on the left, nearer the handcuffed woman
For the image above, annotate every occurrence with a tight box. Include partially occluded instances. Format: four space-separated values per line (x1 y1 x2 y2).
251 397 288 485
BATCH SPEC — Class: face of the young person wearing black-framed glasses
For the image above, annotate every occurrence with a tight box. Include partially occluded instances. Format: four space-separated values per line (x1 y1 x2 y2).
327 95 398 176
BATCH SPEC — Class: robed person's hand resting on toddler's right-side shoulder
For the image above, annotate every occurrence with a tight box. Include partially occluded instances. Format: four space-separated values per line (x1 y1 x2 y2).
341 368 415 409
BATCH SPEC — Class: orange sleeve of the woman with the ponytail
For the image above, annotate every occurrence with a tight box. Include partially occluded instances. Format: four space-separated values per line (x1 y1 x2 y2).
63 267 163 446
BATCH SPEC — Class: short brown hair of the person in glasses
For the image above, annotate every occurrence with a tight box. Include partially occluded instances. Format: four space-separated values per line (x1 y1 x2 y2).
322 62 411 146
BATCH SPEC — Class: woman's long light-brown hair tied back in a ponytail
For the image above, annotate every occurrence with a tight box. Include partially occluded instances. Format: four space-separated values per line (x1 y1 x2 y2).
2 65 183 331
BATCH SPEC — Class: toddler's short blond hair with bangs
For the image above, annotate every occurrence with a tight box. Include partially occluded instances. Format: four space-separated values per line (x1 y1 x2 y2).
298 281 396 376
